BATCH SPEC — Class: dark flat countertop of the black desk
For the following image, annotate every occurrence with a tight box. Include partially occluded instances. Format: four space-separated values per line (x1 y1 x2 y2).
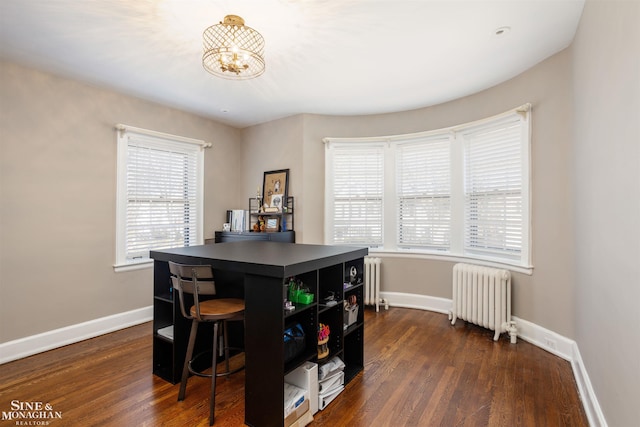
151 241 368 278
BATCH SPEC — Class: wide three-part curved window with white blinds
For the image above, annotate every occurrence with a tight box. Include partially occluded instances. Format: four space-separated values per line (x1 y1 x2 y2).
324 104 531 272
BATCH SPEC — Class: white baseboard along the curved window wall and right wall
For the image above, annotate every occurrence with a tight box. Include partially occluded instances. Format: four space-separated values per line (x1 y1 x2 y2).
380 292 607 427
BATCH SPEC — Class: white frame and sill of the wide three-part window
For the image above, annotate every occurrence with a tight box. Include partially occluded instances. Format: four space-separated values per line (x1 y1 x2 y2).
323 104 533 274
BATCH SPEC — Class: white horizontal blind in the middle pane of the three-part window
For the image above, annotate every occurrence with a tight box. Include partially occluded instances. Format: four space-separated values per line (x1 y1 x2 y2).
396 135 451 251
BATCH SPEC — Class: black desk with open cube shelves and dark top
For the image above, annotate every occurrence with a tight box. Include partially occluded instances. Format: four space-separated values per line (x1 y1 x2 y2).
151 241 368 427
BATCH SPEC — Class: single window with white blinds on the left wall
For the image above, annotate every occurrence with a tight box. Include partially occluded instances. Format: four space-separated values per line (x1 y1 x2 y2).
116 127 204 266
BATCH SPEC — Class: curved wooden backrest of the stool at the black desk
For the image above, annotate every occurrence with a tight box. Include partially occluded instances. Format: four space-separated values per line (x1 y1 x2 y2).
169 261 216 320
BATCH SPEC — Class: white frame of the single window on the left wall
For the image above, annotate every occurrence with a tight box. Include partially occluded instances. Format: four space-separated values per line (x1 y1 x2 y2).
114 124 211 272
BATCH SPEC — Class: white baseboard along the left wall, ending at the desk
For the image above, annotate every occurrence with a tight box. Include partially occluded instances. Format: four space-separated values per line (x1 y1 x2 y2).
0 306 153 364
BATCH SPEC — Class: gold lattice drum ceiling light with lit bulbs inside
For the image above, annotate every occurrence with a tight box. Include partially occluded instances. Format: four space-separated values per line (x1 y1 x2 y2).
202 15 264 80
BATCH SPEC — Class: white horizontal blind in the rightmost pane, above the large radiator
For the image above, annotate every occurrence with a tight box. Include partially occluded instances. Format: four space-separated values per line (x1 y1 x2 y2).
464 117 525 259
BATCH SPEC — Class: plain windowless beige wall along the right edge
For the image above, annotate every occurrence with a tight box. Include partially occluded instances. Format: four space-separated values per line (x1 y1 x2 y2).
572 1 640 426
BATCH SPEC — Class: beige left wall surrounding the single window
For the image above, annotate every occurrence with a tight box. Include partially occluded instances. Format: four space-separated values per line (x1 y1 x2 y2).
0 62 241 342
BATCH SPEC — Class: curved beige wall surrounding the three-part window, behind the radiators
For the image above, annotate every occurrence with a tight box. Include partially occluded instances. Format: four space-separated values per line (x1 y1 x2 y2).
243 51 575 338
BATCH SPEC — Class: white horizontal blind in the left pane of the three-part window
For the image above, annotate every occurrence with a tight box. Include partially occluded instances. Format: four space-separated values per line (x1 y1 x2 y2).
328 146 384 247
